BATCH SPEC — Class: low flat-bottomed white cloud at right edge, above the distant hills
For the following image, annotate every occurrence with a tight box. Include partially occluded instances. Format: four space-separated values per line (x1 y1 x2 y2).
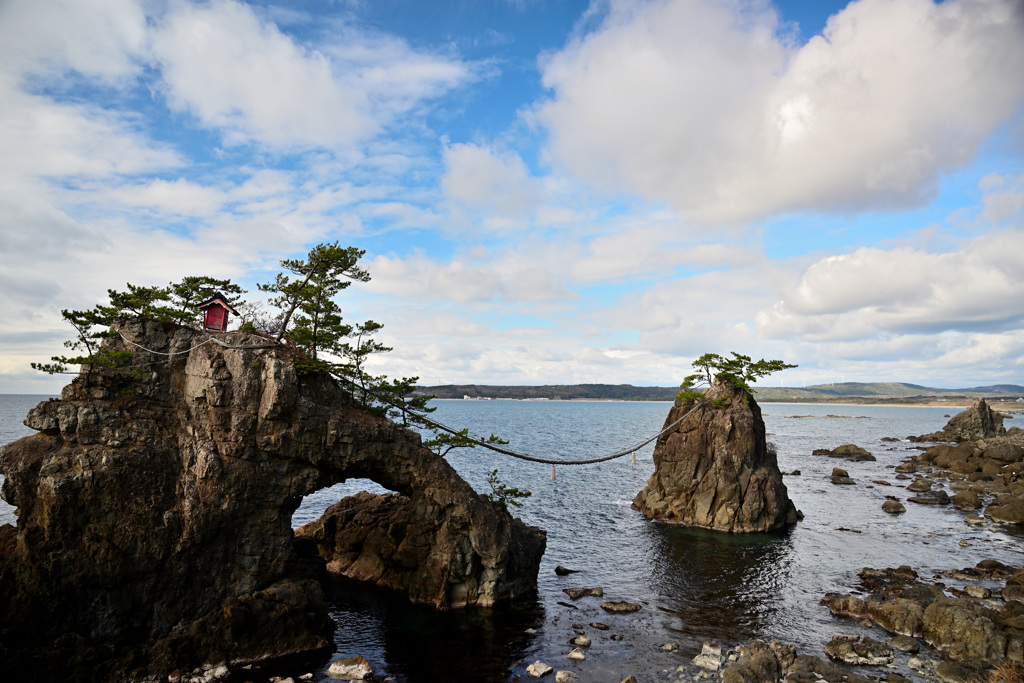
757 228 1024 340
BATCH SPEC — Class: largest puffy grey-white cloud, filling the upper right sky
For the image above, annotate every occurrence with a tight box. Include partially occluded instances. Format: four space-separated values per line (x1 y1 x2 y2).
535 0 1024 221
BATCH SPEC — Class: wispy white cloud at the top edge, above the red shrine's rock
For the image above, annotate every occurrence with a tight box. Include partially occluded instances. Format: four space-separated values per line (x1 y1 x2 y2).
153 0 471 147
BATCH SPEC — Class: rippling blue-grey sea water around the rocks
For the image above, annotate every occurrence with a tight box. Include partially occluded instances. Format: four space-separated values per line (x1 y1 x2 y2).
0 395 1024 683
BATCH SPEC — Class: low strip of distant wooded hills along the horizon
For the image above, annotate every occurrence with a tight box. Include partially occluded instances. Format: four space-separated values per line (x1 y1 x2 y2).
417 382 1024 403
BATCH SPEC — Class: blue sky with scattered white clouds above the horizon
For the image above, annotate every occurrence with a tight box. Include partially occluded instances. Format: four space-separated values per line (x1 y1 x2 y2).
0 0 1024 393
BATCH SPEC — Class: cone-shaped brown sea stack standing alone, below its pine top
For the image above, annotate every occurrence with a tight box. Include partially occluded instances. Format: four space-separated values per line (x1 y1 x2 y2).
633 382 800 532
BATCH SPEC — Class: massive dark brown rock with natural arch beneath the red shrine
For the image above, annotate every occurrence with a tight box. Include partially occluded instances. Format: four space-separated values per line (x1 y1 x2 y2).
0 321 545 681
